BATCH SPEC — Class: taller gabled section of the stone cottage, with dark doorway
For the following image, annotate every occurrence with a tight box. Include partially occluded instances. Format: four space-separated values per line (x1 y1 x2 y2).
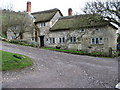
32 8 63 46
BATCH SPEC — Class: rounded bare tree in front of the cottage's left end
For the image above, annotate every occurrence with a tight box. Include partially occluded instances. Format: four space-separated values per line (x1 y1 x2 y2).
9 12 35 39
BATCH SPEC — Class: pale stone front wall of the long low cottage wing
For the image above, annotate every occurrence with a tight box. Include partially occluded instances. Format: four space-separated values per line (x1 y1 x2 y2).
45 26 117 52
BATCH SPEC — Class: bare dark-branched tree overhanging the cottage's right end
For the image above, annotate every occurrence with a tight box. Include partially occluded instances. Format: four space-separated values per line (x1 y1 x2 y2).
83 0 120 27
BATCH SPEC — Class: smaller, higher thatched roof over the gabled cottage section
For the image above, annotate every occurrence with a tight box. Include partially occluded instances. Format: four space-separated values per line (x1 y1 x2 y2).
31 8 62 23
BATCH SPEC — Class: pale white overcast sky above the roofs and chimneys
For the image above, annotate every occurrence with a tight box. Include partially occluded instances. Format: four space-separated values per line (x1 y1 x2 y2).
0 0 106 16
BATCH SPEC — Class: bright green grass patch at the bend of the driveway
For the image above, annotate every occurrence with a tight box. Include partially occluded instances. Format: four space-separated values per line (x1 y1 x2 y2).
0 50 33 71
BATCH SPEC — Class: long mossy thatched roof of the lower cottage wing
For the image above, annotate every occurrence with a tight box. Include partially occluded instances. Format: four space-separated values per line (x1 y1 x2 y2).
50 14 117 31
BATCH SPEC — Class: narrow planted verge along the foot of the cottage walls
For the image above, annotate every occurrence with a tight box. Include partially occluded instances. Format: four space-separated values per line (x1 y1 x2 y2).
2 40 120 58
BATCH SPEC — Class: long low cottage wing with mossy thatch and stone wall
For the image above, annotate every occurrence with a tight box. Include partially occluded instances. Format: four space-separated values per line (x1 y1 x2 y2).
47 14 117 52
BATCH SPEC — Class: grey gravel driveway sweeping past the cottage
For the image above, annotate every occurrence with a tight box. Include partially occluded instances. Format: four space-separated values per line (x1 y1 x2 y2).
2 42 118 88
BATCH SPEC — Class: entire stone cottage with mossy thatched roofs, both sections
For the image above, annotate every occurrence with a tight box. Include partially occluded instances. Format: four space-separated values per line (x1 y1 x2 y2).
32 9 117 52
